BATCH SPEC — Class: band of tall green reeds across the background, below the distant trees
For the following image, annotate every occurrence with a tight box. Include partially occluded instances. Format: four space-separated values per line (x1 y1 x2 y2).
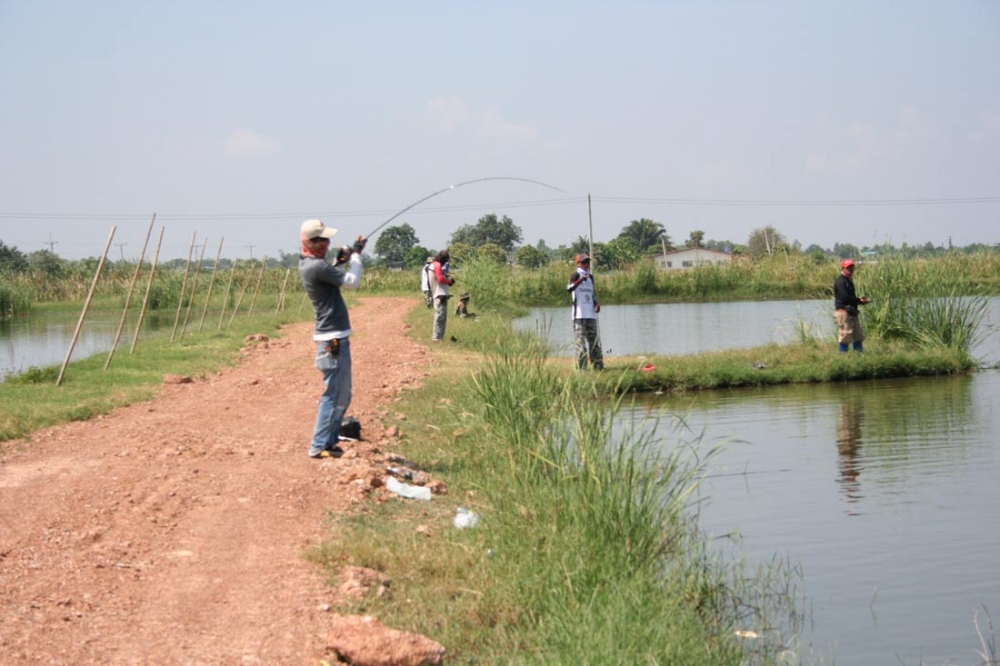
13 252 1000 308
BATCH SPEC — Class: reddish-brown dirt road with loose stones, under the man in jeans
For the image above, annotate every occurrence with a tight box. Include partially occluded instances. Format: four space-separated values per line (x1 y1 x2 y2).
0 298 430 664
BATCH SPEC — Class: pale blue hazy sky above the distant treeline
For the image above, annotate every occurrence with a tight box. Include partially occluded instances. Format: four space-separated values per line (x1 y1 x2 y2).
0 0 1000 258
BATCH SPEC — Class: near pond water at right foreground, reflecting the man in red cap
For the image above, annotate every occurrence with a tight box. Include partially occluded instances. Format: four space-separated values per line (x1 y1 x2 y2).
623 371 1000 666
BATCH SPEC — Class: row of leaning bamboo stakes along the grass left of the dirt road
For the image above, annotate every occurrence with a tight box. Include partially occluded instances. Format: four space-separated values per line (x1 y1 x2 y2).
56 213 291 386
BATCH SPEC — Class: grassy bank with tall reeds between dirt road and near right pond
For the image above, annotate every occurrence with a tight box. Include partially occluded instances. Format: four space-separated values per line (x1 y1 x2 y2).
312 308 797 664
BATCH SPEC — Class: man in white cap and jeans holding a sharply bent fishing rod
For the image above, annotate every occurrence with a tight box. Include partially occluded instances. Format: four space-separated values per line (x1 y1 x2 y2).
299 220 367 458
